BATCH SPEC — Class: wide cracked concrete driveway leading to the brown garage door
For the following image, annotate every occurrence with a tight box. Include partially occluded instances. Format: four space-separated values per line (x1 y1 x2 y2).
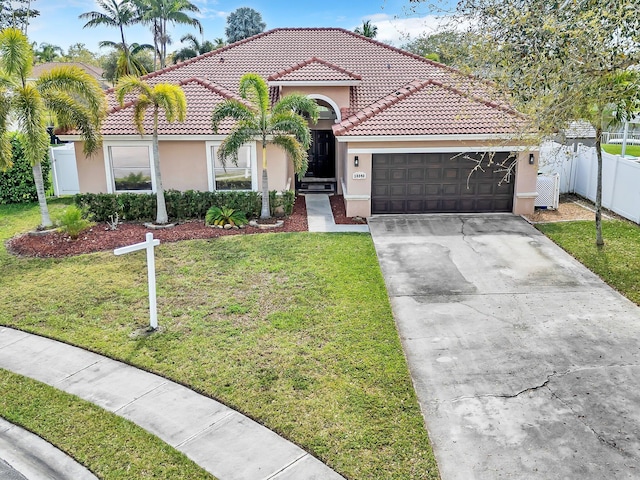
369 214 640 480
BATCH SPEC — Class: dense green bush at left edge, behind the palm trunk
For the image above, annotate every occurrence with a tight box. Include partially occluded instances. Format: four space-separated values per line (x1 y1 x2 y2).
0 134 51 204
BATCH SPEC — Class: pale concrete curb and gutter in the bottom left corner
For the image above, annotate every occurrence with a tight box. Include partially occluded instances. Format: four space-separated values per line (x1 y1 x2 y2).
0 418 97 480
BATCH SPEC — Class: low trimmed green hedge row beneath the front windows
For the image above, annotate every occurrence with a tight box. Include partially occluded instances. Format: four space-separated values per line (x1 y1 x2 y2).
74 190 295 222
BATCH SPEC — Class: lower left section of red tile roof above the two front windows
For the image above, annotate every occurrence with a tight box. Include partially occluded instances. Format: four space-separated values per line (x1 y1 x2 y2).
102 78 242 135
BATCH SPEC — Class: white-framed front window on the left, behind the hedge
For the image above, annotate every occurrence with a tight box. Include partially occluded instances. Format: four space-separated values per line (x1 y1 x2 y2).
109 145 153 192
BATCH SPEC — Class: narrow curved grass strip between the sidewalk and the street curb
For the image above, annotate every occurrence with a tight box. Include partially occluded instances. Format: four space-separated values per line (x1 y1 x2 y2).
0 369 214 480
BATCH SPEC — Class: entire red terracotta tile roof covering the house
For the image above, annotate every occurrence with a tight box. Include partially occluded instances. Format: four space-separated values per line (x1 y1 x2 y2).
99 28 514 135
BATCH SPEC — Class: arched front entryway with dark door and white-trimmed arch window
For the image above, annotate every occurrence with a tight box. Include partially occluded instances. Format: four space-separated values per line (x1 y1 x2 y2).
296 95 340 193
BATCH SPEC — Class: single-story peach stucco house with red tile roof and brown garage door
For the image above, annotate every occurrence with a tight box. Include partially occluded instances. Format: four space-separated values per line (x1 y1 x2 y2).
63 28 537 217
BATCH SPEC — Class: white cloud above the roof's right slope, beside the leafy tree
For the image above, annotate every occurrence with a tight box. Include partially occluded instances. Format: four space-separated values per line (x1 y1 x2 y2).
354 13 451 46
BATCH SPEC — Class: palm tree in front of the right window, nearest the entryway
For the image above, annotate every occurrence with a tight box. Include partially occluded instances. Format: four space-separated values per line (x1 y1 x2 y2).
211 73 318 218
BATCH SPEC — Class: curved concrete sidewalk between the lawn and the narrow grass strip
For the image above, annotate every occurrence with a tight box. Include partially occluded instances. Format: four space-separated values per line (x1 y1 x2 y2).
0 327 343 480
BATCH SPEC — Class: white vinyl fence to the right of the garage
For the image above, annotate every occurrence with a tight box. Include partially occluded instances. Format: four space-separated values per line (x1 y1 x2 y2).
540 142 640 223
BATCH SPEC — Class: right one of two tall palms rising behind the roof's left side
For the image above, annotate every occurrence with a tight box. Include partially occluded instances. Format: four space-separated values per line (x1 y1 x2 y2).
133 0 202 68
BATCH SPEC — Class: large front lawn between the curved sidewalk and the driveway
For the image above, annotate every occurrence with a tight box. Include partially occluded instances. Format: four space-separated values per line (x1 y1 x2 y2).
0 202 438 480
